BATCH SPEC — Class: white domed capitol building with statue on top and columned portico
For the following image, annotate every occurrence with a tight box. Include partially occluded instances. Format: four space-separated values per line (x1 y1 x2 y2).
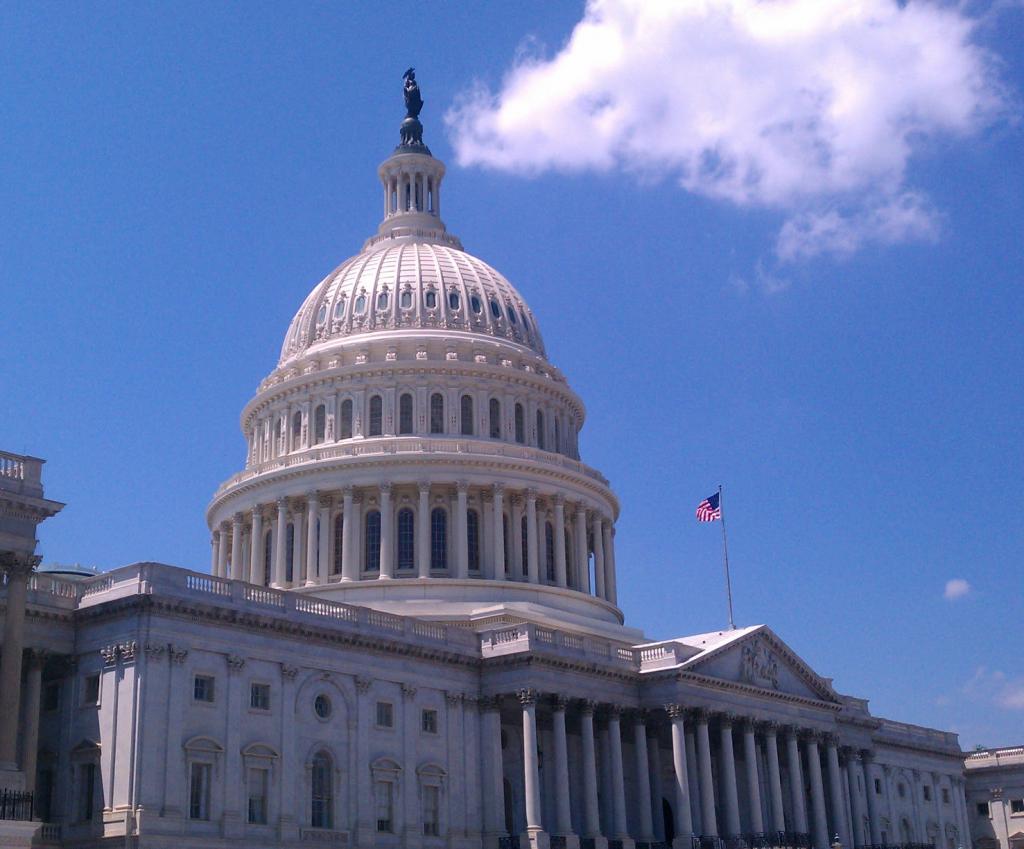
0 75 1007 849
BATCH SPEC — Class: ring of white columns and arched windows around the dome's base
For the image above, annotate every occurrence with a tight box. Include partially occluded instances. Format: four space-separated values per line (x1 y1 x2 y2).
211 481 616 604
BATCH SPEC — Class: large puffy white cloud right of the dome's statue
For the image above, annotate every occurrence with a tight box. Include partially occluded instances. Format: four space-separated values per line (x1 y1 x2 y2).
446 0 1007 261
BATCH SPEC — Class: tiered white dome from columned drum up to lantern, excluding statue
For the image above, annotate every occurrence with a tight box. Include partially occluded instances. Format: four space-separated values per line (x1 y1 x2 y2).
207 119 622 623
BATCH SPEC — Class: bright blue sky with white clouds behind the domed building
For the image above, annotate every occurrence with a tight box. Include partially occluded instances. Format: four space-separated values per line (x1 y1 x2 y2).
0 0 1024 747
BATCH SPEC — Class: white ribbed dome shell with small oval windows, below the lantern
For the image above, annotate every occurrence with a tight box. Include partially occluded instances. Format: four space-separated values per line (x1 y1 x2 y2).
279 239 544 366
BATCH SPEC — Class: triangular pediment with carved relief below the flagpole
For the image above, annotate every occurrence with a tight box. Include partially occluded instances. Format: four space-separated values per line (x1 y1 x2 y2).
683 626 840 703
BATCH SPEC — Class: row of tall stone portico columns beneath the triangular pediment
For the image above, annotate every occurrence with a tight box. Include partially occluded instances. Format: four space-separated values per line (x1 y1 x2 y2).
481 689 950 849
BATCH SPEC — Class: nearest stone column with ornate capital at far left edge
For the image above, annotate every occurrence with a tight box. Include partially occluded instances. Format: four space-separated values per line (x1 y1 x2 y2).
0 552 42 772
